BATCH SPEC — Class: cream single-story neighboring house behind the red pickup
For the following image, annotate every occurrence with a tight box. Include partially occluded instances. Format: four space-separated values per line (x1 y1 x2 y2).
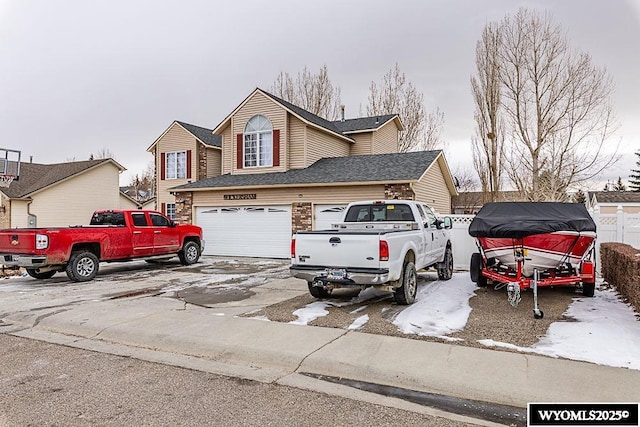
0 159 125 228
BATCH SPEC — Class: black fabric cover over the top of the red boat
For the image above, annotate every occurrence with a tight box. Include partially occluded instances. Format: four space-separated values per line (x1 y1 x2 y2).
469 202 596 238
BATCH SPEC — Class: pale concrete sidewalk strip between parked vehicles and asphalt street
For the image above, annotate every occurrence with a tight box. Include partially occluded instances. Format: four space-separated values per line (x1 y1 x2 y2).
1 290 640 408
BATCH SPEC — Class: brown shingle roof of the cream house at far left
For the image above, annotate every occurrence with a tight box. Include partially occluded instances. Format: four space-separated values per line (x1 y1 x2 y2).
0 159 111 198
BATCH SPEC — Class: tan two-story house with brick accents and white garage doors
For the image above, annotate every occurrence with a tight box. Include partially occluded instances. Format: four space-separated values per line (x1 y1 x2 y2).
148 88 456 258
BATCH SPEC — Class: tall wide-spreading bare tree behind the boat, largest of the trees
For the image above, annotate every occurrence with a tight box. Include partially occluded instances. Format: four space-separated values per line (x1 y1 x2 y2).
499 9 617 200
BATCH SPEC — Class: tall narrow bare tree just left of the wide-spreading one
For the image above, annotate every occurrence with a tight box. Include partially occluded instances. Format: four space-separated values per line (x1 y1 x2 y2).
471 23 505 202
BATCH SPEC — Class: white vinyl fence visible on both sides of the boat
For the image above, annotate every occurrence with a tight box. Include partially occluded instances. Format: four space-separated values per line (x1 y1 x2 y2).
449 206 640 270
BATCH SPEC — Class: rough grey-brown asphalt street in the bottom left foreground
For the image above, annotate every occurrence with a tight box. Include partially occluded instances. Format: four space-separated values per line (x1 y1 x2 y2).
0 333 470 427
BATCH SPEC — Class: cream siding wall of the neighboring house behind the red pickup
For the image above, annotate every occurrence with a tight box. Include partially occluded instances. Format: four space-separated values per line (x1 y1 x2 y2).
24 164 120 227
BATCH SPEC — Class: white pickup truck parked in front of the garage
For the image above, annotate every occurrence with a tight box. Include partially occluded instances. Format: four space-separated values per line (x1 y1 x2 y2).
289 200 453 305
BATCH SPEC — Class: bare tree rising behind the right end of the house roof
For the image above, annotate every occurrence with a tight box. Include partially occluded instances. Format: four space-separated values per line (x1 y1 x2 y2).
367 63 444 152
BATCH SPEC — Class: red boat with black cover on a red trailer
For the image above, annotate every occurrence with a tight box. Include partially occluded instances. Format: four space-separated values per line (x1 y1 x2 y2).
469 202 596 319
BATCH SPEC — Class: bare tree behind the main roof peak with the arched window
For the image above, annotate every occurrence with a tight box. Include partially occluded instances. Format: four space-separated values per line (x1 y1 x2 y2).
271 65 341 120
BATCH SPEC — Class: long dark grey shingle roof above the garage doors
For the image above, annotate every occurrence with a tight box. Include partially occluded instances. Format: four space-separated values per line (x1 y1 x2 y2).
171 150 441 190
